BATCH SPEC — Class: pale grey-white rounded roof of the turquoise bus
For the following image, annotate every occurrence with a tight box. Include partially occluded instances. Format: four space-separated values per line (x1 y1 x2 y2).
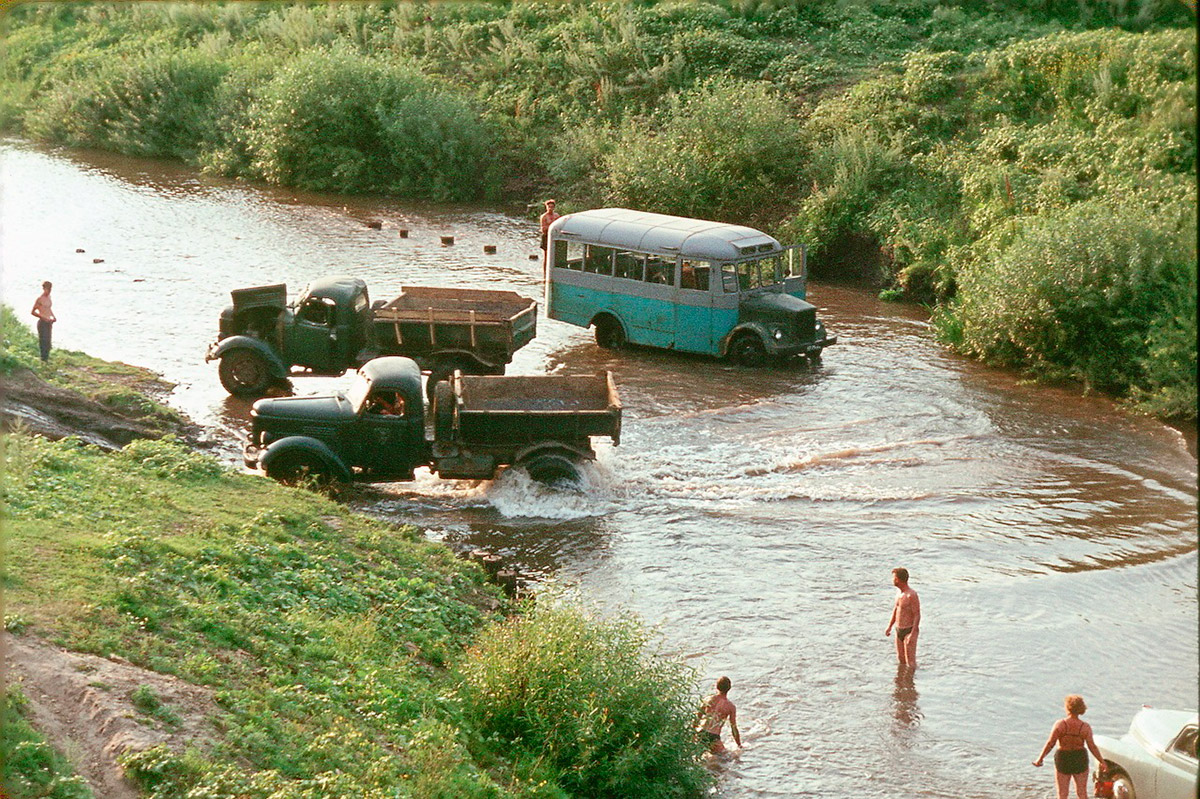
550 208 784 260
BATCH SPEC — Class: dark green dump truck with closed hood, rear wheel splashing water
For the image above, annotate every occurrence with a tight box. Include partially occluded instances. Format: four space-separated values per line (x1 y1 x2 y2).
242 356 620 483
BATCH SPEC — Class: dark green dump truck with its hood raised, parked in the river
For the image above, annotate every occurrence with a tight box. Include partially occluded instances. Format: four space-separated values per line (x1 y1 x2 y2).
205 276 538 397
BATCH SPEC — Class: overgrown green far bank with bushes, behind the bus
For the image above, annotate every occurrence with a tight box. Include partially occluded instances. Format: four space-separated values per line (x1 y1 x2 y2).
0 0 1196 417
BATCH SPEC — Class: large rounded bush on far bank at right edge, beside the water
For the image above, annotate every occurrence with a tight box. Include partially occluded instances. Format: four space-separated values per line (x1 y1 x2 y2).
943 202 1196 407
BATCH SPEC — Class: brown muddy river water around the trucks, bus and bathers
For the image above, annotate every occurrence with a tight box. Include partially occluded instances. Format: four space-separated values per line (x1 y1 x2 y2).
0 143 1198 798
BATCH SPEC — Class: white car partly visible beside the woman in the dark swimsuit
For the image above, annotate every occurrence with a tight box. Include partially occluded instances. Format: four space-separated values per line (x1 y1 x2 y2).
1096 705 1196 799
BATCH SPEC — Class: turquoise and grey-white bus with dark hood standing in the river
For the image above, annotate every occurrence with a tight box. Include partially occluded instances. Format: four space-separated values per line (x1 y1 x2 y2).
546 208 838 365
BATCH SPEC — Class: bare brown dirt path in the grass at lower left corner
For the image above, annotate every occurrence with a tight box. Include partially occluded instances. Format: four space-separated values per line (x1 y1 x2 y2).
0 632 218 799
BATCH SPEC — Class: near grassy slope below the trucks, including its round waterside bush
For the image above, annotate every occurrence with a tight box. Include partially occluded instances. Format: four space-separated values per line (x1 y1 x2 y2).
2 350 709 799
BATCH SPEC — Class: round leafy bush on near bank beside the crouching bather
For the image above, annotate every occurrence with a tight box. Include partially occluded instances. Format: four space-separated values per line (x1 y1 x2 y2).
460 602 709 799
